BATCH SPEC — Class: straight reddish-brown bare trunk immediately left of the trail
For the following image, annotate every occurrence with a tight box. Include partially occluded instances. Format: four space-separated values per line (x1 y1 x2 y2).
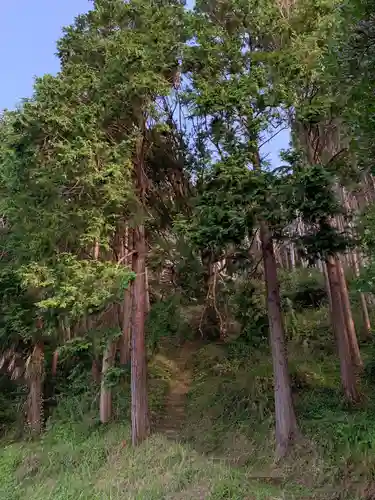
131 226 150 446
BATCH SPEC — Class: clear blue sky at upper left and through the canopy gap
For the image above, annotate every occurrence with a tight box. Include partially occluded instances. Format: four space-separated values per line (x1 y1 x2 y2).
0 0 289 167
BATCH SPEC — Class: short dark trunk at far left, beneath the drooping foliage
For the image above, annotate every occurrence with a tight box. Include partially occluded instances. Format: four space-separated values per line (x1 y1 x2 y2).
25 343 44 435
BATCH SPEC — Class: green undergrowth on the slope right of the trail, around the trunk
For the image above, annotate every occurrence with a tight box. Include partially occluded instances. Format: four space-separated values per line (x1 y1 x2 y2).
185 344 375 500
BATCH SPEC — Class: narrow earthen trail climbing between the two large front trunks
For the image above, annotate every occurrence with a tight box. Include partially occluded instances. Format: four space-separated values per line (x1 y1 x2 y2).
158 342 199 440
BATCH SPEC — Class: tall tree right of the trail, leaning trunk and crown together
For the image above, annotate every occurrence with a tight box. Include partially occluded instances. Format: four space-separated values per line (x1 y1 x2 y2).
182 1 298 456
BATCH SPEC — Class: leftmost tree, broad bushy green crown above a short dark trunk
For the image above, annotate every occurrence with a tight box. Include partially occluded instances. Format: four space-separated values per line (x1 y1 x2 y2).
0 67 135 427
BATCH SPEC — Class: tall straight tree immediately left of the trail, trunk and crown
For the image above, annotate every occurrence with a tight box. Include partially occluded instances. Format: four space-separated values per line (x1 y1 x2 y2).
59 0 184 444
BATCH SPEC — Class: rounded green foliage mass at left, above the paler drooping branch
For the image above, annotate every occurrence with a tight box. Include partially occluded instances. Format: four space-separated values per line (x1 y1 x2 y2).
1 77 131 261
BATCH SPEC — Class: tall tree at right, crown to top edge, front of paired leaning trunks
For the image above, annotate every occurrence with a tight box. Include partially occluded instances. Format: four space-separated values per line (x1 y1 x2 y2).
262 0 362 401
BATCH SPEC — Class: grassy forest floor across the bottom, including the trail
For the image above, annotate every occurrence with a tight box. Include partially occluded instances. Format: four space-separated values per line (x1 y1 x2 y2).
0 342 375 500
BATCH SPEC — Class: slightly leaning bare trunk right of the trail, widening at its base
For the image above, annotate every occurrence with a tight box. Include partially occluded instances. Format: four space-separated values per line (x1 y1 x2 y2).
261 222 298 457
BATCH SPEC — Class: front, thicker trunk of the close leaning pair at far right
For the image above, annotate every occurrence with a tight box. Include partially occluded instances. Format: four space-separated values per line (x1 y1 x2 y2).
326 256 359 402
